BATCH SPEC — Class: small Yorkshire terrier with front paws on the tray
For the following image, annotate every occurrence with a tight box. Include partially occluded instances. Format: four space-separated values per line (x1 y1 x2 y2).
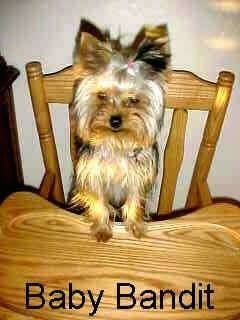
69 23 169 241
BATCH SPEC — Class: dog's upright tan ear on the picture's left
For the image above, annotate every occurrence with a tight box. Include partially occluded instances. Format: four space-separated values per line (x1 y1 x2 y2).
74 32 112 74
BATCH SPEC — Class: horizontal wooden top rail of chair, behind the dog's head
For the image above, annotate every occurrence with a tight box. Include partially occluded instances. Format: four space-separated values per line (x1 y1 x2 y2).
44 66 216 110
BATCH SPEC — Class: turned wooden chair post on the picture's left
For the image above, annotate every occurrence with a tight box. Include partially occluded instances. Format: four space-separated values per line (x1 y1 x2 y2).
26 62 64 203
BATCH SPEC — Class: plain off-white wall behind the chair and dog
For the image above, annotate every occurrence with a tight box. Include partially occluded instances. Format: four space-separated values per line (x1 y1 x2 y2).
0 0 240 207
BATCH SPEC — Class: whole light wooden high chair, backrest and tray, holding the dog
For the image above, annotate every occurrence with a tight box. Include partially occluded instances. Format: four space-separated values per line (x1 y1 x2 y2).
0 62 240 320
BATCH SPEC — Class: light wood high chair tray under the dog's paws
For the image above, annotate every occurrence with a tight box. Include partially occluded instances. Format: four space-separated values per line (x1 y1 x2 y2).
0 193 240 320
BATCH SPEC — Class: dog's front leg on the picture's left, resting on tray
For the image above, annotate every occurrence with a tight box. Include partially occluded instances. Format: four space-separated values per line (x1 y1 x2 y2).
71 191 112 242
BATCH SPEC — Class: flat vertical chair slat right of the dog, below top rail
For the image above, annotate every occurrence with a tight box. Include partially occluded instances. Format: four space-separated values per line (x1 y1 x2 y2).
158 110 188 214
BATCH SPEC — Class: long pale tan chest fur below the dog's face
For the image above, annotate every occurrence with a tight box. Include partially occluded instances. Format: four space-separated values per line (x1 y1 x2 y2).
76 148 156 206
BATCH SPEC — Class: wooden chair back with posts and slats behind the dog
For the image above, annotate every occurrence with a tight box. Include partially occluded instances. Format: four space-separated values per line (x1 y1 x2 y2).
26 62 234 214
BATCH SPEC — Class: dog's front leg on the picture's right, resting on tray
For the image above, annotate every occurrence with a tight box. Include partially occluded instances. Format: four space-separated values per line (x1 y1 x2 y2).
122 196 145 238
